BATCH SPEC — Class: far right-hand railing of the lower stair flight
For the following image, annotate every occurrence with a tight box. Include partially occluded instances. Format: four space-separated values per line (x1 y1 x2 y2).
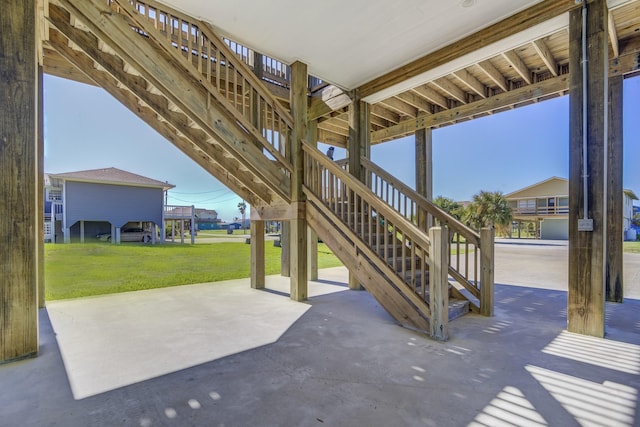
360 158 494 315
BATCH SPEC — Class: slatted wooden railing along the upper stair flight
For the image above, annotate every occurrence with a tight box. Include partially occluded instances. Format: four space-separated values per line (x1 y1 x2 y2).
104 0 293 172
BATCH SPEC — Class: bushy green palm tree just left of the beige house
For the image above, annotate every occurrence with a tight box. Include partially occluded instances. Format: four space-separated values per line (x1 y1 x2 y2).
464 191 513 234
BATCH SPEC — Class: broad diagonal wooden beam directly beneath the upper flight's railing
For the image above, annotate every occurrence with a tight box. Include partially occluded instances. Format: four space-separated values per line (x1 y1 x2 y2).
57 0 290 200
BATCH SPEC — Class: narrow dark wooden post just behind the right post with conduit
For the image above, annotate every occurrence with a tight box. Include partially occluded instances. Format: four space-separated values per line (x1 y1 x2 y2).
605 76 624 302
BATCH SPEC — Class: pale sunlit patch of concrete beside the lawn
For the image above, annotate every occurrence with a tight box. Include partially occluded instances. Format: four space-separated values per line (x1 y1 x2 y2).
47 268 348 399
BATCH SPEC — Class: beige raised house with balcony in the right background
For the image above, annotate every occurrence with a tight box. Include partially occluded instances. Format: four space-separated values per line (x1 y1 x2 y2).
505 176 638 240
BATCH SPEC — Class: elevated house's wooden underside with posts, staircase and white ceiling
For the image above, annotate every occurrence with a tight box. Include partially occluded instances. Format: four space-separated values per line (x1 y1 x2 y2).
0 0 640 361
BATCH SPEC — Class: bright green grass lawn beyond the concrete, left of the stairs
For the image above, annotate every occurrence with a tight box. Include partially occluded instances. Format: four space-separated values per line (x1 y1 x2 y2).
44 241 341 300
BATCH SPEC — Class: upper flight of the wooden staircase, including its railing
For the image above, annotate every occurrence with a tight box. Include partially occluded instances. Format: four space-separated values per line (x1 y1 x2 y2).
45 0 292 205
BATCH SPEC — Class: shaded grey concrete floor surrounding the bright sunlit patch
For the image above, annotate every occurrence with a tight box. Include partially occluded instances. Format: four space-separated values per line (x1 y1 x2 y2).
0 256 640 427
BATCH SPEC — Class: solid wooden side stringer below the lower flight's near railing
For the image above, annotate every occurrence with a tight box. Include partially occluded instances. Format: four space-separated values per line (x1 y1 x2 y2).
305 191 431 334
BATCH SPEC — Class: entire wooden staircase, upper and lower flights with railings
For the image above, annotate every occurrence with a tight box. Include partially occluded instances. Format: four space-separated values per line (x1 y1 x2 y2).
44 0 493 339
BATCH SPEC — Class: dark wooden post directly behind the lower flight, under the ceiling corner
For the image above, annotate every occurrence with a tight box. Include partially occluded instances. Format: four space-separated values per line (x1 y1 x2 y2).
347 92 371 290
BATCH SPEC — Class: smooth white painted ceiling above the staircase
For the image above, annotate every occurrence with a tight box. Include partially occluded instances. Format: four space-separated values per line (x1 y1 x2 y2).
162 0 546 96
